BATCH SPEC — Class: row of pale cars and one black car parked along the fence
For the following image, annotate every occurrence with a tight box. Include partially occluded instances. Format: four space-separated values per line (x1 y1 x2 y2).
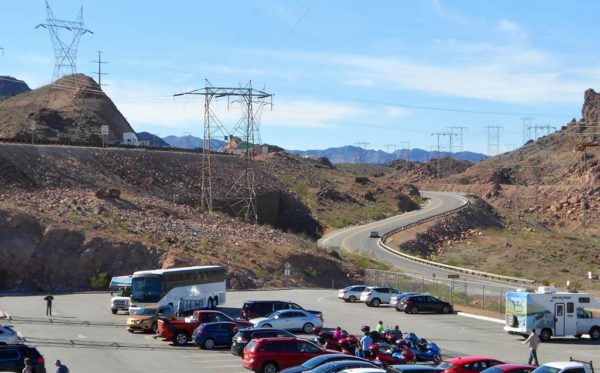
338 285 454 313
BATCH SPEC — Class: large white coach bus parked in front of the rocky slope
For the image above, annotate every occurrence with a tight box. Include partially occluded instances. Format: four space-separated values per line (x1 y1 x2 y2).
130 265 226 312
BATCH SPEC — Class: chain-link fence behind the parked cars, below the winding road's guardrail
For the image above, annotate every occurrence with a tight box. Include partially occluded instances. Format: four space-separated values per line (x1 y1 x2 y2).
364 269 515 314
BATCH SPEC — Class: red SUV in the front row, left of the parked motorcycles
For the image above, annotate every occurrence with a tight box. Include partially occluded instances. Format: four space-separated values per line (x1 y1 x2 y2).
242 337 339 373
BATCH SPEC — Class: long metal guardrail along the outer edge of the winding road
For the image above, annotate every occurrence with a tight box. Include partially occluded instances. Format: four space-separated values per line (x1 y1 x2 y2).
377 197 534 285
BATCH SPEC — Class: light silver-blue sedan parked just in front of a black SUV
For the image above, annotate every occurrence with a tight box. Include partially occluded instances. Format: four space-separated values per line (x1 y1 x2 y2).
250 310 323 334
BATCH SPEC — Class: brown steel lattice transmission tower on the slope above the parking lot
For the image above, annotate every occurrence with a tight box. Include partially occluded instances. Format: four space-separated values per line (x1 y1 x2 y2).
174 80 273 222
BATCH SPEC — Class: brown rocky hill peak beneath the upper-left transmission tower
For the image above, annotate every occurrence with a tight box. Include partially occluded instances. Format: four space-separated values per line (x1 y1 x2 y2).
0 74 133 144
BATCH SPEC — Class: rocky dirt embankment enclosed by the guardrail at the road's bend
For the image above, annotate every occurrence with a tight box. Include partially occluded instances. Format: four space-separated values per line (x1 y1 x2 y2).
386 195 502 258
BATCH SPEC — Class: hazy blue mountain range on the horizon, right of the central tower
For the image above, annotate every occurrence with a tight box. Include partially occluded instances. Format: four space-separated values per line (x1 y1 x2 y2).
288 145 487 164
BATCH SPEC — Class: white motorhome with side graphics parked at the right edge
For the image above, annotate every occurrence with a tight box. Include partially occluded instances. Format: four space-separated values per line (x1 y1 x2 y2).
504 286 600 341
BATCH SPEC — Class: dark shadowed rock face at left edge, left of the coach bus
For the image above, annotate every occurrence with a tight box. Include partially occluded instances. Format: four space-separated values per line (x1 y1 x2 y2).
0 210 160 291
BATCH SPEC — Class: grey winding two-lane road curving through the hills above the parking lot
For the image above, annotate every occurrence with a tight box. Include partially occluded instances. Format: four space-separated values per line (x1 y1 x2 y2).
319 192 515 291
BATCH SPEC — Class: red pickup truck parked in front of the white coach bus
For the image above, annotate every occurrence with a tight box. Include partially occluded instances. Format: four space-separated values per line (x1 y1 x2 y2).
154 310 254 346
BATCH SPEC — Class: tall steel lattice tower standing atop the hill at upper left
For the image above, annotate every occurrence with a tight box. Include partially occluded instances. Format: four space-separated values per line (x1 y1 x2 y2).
35 0 93 82
